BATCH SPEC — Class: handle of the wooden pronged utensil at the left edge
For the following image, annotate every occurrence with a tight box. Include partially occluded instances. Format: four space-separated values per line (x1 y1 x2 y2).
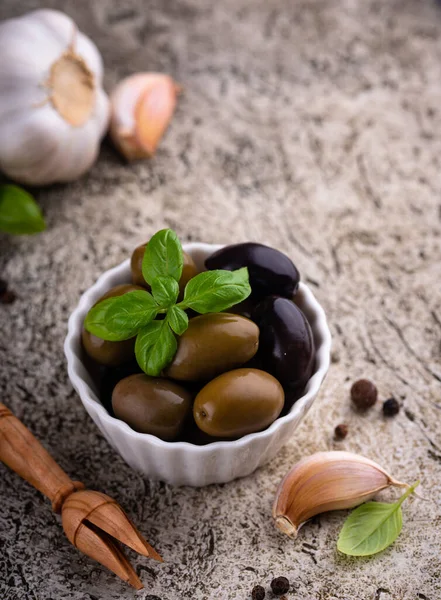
0 402 84 512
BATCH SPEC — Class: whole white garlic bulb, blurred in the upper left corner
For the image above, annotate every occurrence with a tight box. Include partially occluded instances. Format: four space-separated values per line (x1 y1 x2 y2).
0 10 109 184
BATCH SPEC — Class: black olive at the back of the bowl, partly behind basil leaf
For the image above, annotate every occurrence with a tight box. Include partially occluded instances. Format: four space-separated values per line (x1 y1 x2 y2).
205 242 300 299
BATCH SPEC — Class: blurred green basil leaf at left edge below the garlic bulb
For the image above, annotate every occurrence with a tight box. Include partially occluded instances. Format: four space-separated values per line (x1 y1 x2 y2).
0 184 46 235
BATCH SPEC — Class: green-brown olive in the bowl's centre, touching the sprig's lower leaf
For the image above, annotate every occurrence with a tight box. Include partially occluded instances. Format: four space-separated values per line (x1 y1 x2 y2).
165 313 259 381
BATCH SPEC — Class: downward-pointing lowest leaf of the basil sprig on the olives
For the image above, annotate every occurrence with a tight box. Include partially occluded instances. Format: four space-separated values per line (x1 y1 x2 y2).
135 318 178 377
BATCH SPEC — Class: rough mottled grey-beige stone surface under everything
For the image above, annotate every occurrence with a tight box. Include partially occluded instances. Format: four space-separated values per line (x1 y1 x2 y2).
0 0 441 600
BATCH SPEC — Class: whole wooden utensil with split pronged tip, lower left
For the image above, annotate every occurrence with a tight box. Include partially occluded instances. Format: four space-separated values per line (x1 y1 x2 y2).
0 403 162 590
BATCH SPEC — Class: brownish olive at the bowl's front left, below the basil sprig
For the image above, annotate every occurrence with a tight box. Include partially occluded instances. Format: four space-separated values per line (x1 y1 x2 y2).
112 373 193 441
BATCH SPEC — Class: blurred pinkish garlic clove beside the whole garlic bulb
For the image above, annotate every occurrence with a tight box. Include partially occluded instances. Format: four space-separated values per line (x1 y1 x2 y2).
110 73 180 160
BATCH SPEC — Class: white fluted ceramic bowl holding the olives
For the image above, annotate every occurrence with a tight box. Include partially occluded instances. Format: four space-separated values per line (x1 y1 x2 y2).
64 243 331 486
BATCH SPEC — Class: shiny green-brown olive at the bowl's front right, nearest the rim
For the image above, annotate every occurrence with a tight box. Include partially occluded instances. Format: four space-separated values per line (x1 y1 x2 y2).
193 369 285 438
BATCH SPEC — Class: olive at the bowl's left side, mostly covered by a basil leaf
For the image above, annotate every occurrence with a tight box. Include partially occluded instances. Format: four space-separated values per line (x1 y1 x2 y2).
81 283 144 367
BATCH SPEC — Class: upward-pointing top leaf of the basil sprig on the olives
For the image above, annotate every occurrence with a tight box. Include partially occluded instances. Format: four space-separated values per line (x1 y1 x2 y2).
142 229 184 285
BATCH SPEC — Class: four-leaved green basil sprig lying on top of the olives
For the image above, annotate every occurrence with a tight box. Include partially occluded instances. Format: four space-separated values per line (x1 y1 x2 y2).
84 229 251 376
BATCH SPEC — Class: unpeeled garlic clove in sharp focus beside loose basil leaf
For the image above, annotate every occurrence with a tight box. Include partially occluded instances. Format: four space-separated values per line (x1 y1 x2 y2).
273 451 407 537
